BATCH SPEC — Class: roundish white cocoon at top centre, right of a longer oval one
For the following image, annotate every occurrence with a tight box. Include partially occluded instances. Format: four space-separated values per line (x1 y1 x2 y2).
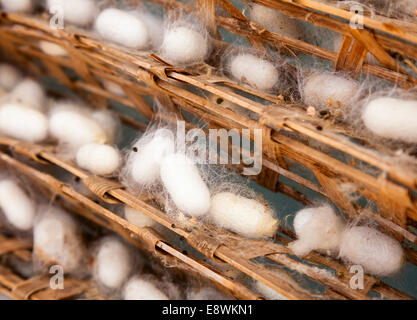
161 26 209 64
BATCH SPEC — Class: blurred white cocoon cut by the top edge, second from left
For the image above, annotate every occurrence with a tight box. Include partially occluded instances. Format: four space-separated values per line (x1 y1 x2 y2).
47 0 97 27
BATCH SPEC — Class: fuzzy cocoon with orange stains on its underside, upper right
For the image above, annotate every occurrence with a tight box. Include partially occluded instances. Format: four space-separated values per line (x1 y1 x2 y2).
302 73 360 107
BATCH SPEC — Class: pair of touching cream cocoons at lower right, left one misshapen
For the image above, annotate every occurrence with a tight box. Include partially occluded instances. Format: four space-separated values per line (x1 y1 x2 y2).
288 206 404 276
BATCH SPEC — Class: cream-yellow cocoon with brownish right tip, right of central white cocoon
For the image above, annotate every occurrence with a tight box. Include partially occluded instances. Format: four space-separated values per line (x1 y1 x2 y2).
210 192 278 238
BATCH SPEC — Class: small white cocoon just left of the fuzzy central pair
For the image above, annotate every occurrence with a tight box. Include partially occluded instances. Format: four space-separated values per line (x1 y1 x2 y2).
76 142 121 176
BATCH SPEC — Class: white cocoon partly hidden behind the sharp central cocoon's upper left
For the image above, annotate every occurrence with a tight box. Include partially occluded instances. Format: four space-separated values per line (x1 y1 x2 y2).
127 129 175 185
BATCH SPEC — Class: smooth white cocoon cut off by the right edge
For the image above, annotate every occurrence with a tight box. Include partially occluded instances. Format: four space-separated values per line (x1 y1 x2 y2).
362 97 417 143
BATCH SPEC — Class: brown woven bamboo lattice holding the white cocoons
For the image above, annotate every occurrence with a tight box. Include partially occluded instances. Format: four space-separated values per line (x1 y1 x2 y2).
0 0 417 299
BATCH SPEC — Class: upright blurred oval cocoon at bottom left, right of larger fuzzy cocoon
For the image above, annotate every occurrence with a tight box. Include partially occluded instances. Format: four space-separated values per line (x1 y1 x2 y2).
96 237 132 289
